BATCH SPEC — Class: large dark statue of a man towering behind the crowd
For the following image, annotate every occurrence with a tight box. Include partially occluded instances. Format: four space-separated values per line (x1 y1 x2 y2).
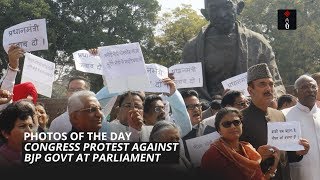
182 0 285 101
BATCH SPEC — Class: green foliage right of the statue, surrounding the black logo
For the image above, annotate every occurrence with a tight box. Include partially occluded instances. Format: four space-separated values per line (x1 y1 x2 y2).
240 0 320 85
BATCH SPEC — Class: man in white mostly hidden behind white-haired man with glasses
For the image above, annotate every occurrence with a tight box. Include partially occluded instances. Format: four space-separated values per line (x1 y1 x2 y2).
49 77 90 133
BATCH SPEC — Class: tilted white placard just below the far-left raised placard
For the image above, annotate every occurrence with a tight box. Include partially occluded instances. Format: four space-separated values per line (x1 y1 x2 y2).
21 53 55 97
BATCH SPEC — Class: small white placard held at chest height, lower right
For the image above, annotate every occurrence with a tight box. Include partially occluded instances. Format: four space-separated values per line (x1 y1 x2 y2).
268 121 304 151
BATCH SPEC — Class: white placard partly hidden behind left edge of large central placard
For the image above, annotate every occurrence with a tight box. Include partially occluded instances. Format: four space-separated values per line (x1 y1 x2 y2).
72 50 102 75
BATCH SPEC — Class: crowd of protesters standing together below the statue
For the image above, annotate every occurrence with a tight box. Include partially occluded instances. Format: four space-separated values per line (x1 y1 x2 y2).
0 45 320 179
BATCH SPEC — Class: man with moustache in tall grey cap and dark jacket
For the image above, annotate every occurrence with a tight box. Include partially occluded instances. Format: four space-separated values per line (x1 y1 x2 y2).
240 63 305 180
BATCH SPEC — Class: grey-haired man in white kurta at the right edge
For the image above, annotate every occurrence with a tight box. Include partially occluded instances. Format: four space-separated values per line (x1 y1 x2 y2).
282 75 320 180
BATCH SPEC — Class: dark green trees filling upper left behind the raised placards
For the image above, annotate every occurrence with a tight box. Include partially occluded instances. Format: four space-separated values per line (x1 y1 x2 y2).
0 0 160 92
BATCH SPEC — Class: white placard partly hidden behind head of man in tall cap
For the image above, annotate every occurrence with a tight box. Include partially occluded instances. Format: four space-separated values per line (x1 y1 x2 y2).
221 72 250 96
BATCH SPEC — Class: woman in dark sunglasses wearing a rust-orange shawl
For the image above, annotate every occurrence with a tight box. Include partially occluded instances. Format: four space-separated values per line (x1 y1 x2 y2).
201 107 280 180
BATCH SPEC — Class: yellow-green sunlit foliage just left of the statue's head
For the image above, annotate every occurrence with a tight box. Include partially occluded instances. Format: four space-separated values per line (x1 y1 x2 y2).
149 5 207 67
